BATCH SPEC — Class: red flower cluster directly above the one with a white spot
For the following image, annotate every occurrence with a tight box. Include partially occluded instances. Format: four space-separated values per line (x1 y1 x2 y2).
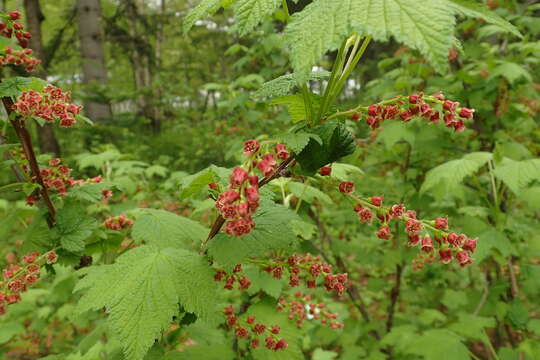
263 254 348 295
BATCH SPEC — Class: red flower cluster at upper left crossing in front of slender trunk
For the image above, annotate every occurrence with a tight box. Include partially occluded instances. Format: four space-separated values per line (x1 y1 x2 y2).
13 85 82 127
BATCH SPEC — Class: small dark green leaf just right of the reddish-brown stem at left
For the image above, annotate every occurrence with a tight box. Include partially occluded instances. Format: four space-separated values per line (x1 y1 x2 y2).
53 201 98 252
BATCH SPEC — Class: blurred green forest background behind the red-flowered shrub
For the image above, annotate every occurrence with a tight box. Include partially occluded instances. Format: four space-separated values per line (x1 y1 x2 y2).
0 0 540 360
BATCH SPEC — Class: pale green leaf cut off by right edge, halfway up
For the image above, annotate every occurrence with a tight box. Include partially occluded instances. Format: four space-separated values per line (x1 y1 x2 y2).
494 159 540 194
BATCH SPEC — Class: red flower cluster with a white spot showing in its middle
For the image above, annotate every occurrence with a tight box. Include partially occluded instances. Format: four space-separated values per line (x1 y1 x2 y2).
277 291 343 329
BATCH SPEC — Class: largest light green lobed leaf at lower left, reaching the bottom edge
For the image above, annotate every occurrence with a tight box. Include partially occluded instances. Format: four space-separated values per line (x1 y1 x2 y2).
75 246 216 360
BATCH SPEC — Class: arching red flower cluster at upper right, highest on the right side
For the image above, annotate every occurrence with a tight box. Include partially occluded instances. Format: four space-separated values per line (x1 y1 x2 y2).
351 93 474 132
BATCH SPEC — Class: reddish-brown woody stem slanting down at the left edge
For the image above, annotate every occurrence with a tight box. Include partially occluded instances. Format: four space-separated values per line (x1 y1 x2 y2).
2 96 56 227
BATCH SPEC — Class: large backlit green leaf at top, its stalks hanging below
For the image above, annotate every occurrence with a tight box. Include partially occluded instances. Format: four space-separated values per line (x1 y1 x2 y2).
285 0 455 79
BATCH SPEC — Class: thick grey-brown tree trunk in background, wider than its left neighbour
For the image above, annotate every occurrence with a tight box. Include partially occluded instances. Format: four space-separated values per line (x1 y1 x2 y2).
77 0 111 122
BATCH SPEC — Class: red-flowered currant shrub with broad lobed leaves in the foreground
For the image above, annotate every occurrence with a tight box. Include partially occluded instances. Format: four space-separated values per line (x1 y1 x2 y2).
0 0 540 360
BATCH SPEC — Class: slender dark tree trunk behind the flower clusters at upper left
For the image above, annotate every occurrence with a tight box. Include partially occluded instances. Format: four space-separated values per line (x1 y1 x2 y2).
24 0 60 156
